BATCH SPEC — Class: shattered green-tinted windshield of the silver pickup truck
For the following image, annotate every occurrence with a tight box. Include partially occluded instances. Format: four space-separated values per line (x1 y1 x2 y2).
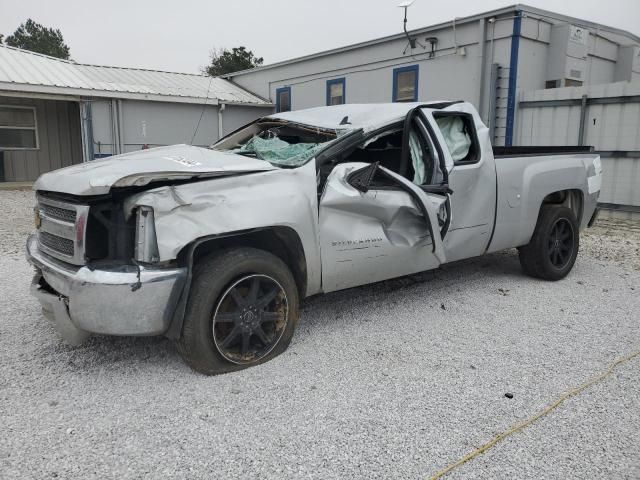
213 119 338 167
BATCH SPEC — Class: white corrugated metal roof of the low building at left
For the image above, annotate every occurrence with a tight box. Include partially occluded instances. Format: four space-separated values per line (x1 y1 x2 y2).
0 45 272 106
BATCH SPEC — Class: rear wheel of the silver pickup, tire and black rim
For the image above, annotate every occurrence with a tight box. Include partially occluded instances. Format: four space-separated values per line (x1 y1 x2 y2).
518 205 580 281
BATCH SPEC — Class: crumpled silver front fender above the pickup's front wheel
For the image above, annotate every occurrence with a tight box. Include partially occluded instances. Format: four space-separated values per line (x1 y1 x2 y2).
124 162 320 291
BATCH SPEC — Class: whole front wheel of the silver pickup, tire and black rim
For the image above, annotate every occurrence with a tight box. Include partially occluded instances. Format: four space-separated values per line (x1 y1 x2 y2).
176 248 299 375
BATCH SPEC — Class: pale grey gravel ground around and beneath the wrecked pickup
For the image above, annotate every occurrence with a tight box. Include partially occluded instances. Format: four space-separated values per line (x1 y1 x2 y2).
0 191 640 479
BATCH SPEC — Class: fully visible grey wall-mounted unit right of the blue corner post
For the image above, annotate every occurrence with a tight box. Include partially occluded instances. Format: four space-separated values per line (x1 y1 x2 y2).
546 24 589 88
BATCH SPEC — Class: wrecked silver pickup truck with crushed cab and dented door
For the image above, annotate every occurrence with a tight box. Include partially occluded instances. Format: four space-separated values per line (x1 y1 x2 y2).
27 102 601 374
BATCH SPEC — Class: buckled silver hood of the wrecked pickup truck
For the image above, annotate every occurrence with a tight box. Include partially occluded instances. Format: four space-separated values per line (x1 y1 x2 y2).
33 145 276 195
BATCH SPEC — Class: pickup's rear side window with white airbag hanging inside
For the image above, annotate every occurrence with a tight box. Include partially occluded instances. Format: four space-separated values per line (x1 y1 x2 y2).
433 113 480 165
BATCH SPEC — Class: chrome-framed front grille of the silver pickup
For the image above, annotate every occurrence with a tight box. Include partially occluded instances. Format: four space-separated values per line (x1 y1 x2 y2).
36 194 89 265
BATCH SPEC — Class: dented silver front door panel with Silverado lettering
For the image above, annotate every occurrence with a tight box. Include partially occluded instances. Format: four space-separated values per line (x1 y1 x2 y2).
319 163 442 292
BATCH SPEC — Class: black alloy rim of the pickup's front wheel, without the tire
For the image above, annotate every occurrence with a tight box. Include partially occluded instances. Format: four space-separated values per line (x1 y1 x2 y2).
213 274 289 364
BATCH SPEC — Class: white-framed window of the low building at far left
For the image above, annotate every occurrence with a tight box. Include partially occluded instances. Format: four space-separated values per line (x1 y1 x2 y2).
0 105 38 150
